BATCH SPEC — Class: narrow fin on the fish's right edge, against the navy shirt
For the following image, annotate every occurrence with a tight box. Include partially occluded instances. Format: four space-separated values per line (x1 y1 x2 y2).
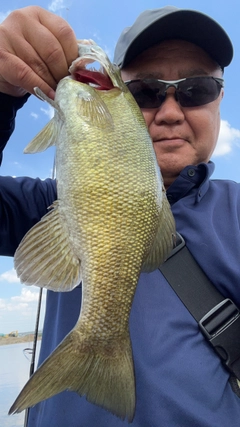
142 192 176 273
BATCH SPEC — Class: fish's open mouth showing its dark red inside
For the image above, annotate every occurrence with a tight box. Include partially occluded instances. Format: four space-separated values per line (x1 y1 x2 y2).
71 68 114 90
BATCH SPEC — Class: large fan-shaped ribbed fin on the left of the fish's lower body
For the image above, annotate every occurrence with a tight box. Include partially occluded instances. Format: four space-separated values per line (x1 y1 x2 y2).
14 201 81 292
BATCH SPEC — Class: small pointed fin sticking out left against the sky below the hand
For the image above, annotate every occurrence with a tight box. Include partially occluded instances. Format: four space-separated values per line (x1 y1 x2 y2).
24 117 58 154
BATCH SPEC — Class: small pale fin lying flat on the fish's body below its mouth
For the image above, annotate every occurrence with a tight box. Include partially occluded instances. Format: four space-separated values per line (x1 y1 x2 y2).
77 86 114 131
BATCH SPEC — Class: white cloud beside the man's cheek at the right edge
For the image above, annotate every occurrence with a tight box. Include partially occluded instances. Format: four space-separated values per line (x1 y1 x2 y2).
213 120 240 156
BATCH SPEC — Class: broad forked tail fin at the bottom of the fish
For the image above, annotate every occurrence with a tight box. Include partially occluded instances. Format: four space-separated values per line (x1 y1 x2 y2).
9 329 135 422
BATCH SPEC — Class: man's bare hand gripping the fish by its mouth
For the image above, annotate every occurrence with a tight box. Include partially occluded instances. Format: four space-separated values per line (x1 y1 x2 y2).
0 6 78 98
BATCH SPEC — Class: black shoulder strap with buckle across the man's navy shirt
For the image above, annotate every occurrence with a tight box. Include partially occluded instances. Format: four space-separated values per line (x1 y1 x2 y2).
159 233 240 379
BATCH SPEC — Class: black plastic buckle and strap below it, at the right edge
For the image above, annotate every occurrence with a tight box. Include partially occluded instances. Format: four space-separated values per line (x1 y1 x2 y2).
199 298 240 379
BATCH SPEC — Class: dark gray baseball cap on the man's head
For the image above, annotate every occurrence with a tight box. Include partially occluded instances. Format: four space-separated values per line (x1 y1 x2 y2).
113 6 233 68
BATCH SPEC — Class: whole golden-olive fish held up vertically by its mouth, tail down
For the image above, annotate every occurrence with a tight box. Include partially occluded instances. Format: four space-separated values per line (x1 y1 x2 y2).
9 42 175 422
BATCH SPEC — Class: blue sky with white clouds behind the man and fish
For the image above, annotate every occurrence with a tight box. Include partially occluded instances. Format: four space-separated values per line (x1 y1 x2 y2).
0 0 240 333
